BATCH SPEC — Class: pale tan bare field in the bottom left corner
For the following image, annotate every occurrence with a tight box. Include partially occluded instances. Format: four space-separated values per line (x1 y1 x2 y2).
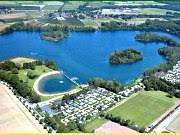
0 84 46 133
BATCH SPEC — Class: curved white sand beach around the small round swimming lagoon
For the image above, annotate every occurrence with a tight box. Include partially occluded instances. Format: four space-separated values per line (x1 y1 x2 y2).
33 71 78 97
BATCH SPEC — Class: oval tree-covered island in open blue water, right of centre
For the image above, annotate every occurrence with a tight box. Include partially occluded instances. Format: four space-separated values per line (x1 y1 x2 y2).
109 48 143 64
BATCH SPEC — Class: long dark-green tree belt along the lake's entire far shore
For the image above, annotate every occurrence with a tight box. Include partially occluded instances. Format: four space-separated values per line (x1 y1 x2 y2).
1 20 180 36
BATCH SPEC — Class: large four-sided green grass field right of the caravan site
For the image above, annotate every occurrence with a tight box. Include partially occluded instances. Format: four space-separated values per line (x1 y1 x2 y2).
108 91 176 127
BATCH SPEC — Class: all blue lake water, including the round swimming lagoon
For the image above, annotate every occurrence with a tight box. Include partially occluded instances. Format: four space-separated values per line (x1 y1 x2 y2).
0 31 179 93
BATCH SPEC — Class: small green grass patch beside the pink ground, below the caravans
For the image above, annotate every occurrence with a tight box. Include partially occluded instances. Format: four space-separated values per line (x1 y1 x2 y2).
85 118 107 132
